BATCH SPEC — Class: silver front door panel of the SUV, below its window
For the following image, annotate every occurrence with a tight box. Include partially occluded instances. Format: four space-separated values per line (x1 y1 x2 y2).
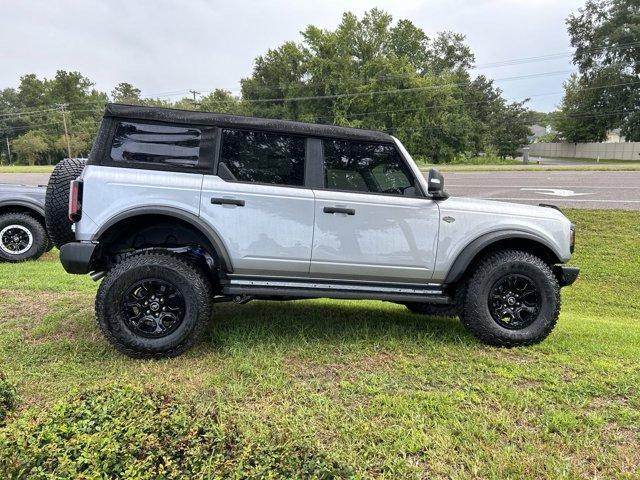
311 190 439 282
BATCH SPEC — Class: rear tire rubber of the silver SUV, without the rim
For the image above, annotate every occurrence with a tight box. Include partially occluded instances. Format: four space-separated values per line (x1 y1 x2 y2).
96 251 213 359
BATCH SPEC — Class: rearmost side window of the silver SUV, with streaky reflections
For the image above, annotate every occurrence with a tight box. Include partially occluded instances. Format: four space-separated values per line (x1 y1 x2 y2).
111 122 202 167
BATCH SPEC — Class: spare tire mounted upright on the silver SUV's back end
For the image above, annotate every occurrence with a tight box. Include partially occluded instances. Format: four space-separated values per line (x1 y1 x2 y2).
44 158 87 248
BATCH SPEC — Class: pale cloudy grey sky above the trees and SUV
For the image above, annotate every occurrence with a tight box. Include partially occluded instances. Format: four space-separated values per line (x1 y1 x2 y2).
0 0 584 111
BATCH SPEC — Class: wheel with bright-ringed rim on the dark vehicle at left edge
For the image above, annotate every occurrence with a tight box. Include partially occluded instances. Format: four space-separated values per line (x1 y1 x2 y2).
0 213 47 262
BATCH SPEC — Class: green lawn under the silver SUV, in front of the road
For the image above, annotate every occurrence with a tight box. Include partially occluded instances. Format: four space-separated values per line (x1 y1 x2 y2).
0 210 640 479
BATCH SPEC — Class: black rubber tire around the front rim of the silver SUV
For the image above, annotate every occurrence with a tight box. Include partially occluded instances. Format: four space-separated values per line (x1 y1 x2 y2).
461 250 560 347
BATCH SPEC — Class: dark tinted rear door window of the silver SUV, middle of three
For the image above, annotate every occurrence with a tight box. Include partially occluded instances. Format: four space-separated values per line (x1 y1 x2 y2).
220 129 305 186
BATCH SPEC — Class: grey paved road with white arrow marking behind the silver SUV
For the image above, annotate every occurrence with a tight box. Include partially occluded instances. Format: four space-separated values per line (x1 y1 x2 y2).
0 171 640 210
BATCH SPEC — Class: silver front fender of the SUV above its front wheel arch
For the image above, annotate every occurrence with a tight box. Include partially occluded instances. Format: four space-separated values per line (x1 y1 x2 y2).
433 198 571 281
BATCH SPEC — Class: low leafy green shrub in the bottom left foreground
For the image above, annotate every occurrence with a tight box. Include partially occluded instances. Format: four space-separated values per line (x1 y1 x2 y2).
0 385 350 479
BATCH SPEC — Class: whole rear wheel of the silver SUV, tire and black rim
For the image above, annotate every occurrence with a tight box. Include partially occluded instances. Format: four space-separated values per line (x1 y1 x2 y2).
96 251 213 358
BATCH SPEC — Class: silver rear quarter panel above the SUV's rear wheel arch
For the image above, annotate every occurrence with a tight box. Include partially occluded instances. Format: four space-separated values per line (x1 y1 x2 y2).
76 165 203 241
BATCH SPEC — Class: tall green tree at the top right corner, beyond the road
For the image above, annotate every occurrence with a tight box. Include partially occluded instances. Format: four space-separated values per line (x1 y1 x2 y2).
557 0 640 141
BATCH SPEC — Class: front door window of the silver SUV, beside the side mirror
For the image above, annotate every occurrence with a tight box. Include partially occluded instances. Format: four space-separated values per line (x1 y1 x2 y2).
323 140 415 195
